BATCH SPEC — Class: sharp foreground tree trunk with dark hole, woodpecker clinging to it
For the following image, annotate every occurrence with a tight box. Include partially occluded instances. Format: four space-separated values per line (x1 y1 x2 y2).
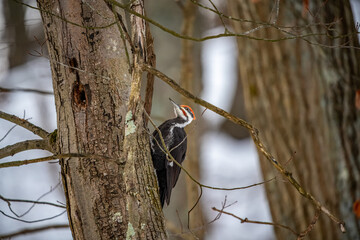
38 0 166 240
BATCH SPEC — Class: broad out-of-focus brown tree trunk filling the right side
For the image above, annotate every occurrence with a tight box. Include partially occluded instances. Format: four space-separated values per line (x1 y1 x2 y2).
229 0 360 239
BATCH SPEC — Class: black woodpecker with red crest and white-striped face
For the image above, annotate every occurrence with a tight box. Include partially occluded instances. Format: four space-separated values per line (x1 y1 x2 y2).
150 99 196 207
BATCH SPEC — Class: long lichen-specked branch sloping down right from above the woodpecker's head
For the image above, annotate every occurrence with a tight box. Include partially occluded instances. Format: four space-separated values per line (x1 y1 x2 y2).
142 64 345 232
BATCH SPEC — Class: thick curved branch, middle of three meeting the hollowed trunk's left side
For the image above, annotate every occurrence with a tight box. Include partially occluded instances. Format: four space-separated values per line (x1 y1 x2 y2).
0 139 52 159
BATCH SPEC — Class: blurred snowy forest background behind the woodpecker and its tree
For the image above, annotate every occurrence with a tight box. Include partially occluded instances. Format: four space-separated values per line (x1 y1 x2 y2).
0 0 360 240
